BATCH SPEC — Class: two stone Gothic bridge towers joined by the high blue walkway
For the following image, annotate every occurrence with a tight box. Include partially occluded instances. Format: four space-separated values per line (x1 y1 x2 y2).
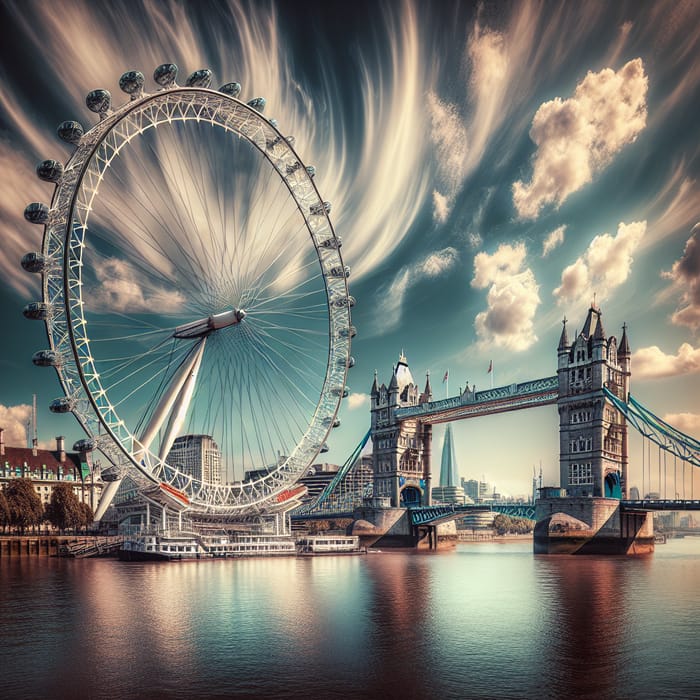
370 305 631 507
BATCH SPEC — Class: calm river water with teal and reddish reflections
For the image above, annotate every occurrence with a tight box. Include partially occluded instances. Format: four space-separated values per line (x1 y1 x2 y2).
0 538 700 700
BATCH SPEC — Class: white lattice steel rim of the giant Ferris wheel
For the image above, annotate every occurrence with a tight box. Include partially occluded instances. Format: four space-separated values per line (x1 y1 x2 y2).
32 78 351 512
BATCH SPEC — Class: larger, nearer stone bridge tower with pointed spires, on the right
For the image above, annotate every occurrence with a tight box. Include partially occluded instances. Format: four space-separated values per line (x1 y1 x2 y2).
557 305 630 498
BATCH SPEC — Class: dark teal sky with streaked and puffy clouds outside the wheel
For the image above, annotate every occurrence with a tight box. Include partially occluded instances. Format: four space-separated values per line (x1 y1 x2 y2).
0 0 700 497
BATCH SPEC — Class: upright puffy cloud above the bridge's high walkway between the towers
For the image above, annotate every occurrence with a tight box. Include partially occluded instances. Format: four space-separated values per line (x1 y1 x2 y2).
471 243 540 351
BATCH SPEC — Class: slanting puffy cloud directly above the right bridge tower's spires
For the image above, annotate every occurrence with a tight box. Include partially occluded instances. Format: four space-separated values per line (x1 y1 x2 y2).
554 221 647 304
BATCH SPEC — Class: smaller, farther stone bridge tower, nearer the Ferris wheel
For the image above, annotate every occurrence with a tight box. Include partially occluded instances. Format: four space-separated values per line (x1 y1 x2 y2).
370 352 432 508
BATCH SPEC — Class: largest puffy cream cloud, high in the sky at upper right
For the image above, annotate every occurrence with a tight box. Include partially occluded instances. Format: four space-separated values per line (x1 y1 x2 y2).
513 58 648 219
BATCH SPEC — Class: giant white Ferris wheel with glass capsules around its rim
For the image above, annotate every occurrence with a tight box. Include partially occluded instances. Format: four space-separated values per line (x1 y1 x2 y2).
22 64 355 516
